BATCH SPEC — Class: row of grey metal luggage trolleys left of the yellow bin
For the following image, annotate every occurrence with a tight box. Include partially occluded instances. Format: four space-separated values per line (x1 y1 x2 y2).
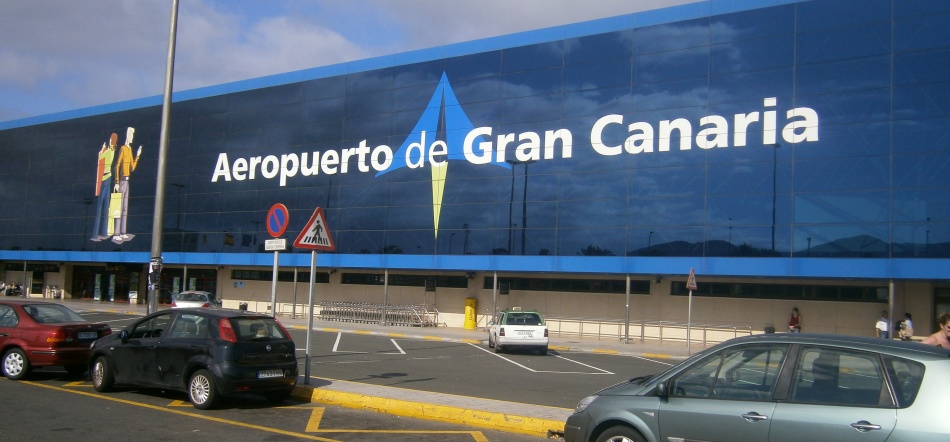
315 302 439 327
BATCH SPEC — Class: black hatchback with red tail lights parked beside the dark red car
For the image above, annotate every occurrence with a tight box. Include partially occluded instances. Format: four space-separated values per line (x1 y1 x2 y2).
89 309 297 410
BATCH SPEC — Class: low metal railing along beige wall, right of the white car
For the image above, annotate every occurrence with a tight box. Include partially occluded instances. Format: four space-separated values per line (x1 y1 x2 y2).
545 317 752 346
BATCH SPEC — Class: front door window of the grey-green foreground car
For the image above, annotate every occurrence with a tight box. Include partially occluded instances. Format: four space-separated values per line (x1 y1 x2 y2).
669 345 788 401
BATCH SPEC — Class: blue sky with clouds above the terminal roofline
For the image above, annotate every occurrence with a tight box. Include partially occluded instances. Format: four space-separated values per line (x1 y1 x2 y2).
0 0 696 121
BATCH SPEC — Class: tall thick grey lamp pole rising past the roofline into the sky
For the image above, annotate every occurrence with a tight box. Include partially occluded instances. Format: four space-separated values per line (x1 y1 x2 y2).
146 0 178 313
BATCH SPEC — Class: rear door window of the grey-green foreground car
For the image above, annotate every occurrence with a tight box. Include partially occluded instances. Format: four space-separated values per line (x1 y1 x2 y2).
790 347 891 407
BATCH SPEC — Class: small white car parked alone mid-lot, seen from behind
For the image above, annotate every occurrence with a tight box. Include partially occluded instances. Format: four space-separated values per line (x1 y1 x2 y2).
488 307 549 356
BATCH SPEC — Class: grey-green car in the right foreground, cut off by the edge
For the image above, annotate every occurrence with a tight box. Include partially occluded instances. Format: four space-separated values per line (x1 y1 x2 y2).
564 333 950 442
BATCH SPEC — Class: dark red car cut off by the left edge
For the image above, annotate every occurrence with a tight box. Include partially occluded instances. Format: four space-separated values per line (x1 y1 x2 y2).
0 299 112 380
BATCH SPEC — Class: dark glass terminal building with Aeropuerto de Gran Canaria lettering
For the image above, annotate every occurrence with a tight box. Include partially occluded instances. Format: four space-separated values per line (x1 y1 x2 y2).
0 0 950 335
